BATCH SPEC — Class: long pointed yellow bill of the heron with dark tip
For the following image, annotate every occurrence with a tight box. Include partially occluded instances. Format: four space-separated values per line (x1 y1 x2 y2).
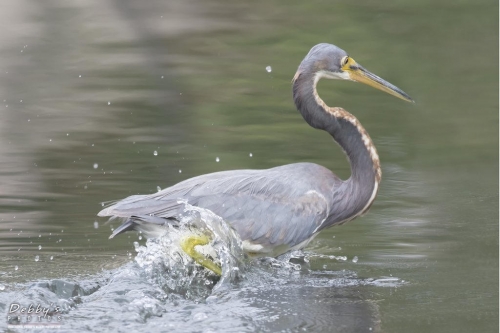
342 58 415 103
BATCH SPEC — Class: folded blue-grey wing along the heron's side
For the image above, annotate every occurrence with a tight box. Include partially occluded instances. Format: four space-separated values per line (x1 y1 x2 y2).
98 163 340 248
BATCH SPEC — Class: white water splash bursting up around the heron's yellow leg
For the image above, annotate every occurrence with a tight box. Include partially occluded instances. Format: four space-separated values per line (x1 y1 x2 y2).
134 203 245 300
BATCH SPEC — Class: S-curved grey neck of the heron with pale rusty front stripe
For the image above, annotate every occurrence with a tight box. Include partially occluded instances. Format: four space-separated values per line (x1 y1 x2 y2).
293 72 381 220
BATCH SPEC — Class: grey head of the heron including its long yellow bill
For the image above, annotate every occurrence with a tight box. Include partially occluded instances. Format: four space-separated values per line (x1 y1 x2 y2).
294 43 414 103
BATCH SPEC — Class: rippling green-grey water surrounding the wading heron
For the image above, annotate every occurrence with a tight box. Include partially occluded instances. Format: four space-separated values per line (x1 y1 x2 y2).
0 0 499 333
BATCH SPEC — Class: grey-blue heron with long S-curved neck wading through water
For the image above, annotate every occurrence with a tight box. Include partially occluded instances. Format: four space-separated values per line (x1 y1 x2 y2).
98 44 413 275
